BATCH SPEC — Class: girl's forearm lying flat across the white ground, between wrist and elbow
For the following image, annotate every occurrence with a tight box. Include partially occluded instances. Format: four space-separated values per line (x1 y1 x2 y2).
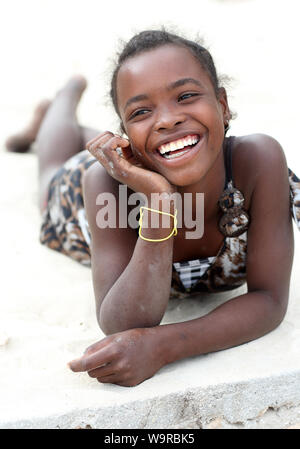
155 291 285 364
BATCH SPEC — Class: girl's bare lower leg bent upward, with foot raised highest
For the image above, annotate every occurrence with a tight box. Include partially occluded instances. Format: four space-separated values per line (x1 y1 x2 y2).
37 76 99 212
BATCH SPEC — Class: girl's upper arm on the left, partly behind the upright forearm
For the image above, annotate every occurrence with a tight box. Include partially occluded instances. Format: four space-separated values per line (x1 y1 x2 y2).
83 162 137 317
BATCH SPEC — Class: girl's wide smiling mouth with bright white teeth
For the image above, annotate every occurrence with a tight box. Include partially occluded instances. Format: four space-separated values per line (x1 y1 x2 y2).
155 134 203 166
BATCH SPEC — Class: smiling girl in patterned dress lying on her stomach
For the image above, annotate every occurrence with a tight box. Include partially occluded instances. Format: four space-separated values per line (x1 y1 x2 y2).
6 30 300 386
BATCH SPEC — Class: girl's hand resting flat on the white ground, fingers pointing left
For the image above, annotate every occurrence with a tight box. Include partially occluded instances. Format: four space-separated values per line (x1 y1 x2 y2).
68 328 165 387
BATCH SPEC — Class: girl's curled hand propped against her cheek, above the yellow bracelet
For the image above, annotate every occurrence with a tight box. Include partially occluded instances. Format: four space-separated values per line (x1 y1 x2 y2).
86 131 176 198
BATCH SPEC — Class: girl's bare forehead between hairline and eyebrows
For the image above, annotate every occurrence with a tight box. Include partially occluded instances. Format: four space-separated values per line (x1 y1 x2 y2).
116 45 213 109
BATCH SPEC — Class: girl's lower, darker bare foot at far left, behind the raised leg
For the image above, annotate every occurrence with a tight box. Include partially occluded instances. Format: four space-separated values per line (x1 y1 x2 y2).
5 100 51 153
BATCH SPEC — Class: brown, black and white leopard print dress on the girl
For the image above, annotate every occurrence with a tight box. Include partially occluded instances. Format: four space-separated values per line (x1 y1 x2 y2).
40 137 300 298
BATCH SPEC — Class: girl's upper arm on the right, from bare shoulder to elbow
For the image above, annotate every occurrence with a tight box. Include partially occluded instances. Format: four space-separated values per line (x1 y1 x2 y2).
247 135 294 314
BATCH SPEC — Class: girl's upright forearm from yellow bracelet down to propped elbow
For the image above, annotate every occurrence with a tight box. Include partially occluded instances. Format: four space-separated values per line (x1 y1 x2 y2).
98 199 173 334
